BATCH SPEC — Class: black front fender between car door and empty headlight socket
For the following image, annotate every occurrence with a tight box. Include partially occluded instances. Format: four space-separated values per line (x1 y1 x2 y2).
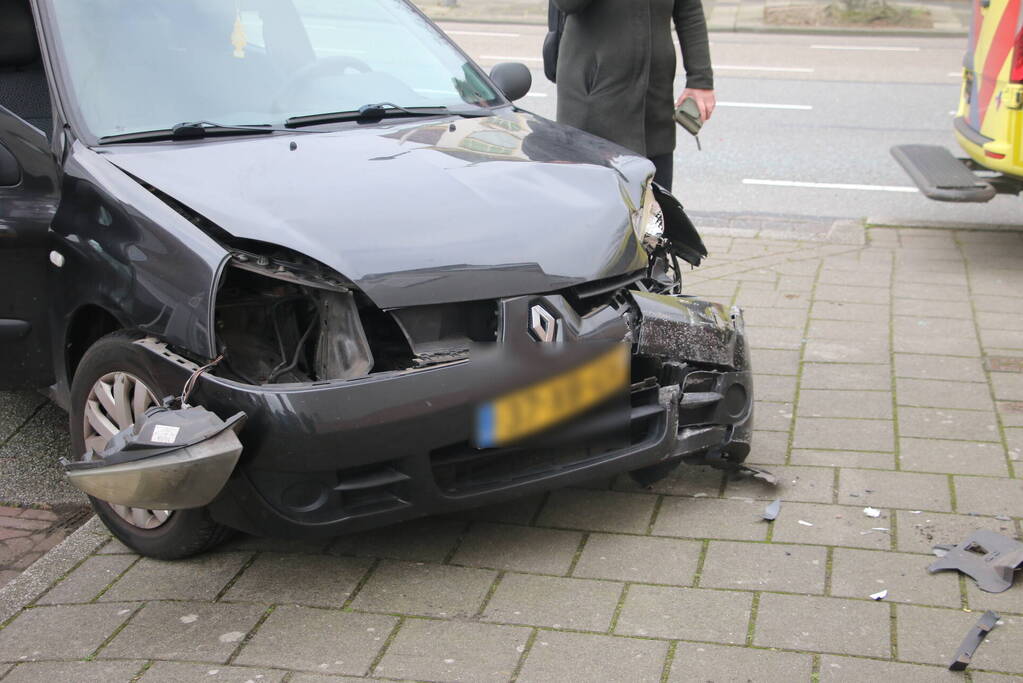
52 143 228 367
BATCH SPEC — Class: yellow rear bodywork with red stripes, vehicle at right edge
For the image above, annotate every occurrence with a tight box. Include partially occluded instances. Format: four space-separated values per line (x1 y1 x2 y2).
955 0 1023 178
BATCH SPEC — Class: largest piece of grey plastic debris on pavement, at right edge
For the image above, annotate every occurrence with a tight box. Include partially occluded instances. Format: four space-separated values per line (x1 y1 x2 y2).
927 530 1023 593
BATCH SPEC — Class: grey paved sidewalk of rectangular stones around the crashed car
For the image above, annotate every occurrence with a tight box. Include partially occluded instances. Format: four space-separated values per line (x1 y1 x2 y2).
0 229 1023 683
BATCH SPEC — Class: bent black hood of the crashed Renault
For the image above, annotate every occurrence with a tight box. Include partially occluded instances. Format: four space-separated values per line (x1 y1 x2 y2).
98 108 653 308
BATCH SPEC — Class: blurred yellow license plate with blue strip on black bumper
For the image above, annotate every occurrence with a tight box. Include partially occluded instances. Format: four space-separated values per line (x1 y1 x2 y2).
476 344 629 448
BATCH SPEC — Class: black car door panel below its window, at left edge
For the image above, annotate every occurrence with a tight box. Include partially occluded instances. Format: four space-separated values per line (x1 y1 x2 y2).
0 107 57 390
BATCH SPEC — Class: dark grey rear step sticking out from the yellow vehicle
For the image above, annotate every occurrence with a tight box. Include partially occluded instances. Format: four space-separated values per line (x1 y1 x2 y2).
891 144 997 202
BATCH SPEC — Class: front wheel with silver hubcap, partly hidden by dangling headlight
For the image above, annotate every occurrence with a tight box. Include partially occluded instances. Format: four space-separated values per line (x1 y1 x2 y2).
70 332 230 559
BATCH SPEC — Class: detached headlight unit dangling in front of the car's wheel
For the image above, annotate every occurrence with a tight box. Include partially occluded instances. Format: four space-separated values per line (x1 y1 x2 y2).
63 407 246 510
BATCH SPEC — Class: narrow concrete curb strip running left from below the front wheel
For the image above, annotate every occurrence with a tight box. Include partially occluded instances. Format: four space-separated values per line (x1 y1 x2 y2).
0 515 110 624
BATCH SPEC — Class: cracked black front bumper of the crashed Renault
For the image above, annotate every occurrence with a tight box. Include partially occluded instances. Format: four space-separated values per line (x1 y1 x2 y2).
138 294 753 536
